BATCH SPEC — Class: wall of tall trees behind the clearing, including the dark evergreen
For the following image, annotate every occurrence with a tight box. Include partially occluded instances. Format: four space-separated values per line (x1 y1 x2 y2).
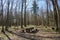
0 0 60 31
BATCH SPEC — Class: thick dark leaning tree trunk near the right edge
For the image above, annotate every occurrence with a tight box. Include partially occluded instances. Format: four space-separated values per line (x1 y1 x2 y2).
51 0 59 31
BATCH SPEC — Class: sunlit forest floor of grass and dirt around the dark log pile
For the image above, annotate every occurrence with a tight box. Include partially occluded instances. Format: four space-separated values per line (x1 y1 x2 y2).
0 27 60 40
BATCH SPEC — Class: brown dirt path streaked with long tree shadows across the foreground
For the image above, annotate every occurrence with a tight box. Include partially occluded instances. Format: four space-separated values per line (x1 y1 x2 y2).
10 32 60 40
